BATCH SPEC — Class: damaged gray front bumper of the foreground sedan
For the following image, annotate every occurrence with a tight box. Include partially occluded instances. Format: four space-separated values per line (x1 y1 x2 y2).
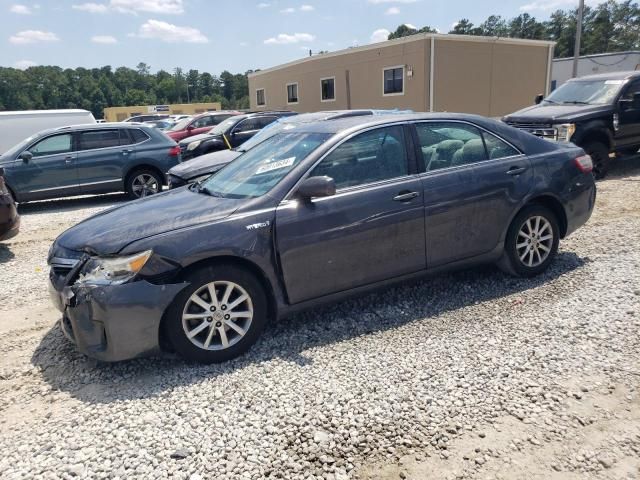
49 278 187 362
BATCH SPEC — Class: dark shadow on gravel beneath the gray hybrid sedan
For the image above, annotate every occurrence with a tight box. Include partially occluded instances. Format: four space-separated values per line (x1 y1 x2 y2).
31 252 587 403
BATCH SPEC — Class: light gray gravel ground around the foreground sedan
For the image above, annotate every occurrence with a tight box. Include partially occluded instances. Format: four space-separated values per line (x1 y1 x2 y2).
0 159 640 480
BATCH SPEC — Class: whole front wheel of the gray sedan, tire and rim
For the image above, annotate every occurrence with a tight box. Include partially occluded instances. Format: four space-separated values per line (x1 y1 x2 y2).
164 264 268 363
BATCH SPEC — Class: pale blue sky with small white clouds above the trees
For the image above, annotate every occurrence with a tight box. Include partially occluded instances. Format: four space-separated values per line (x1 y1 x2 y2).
0 0 597 74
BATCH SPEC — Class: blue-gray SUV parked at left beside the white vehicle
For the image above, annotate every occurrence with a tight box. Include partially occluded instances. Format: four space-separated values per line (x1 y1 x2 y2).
0 123 180 202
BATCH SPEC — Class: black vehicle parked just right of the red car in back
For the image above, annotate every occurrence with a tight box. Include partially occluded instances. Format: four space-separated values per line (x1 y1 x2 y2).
179 111 296 161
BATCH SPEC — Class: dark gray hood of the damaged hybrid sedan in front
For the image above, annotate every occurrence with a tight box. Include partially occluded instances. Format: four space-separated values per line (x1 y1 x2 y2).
56 188 244 255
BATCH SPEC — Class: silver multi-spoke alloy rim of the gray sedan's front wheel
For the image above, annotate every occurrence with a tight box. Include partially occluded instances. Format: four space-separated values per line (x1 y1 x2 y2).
182 281 253 350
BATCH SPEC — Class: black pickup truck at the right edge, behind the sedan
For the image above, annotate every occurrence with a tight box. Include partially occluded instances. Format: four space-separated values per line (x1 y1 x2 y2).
503 71 640 178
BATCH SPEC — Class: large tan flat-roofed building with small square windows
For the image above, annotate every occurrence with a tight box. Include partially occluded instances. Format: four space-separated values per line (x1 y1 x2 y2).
249 34 555 116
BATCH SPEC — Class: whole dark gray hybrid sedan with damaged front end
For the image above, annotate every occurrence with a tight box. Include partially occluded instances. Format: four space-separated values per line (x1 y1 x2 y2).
49 114 596 362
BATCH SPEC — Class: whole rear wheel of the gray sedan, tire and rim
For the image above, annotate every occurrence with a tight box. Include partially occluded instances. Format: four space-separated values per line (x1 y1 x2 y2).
498 205 560 277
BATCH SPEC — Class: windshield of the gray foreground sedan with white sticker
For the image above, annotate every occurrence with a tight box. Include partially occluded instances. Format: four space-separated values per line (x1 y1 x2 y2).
201 133 331 198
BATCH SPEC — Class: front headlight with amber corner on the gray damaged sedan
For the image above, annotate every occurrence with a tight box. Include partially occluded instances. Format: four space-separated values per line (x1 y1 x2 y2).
76 250 153 285
